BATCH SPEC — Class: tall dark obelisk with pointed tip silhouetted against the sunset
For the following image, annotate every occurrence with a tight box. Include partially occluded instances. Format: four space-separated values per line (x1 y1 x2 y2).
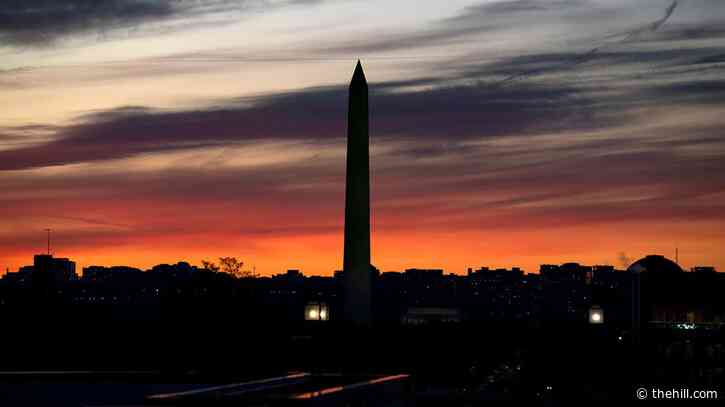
343 61 372 325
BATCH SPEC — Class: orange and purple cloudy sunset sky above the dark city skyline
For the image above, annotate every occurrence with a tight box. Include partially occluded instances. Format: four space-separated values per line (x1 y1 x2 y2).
0 0 725 275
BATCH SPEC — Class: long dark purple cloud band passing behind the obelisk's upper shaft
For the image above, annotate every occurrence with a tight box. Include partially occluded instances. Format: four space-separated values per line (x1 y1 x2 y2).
0 79 604 171
